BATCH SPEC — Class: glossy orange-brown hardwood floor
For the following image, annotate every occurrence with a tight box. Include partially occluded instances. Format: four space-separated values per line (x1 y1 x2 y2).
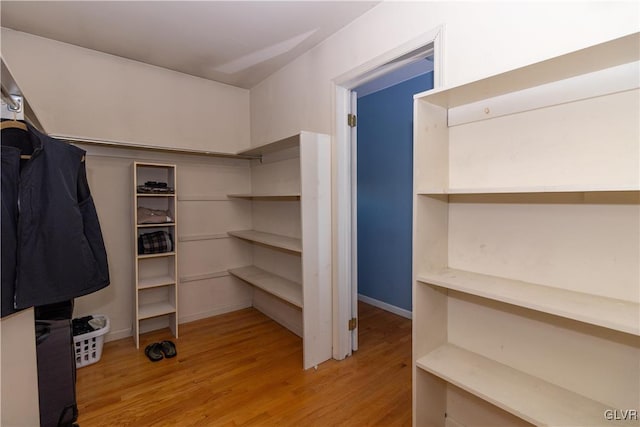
77 303 411 427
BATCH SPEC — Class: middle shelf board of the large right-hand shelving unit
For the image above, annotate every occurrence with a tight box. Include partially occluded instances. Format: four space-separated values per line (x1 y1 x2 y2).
417 268 640 335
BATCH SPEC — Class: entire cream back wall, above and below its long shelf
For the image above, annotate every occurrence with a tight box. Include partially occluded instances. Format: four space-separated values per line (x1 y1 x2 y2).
2 28 260 340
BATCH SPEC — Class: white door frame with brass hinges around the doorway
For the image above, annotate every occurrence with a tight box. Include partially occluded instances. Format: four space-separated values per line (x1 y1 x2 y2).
333 26 444 360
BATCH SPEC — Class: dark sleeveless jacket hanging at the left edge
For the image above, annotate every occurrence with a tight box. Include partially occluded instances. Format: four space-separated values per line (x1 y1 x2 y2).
0 122 109 317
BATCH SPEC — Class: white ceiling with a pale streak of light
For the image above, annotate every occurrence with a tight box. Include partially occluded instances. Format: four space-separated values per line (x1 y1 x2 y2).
0 0 379 88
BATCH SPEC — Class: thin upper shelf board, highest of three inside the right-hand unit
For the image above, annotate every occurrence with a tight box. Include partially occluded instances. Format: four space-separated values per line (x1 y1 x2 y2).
417 183 640 196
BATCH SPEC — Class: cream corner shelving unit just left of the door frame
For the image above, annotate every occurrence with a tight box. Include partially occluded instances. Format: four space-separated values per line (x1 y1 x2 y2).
227 132 332 369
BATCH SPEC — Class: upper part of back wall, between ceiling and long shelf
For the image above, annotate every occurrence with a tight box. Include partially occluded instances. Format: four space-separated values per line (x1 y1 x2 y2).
2 28 249 153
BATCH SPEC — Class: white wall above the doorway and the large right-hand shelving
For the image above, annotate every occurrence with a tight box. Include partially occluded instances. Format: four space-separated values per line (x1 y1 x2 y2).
251 1 640 146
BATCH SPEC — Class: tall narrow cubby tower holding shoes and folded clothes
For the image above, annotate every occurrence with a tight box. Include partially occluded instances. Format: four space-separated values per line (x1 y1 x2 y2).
133 162 178 348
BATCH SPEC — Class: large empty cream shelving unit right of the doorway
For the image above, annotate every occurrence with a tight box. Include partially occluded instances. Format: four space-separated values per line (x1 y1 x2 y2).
413 34 640 426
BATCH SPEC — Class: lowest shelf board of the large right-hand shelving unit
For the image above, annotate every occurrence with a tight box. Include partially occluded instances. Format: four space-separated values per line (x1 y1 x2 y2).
416 344 629 426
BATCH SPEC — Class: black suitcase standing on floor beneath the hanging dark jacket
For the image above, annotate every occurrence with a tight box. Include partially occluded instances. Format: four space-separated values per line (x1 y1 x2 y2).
36 319 78 427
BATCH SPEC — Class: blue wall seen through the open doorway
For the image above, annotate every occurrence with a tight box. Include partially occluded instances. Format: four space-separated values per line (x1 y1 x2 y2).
357 73 433 311
